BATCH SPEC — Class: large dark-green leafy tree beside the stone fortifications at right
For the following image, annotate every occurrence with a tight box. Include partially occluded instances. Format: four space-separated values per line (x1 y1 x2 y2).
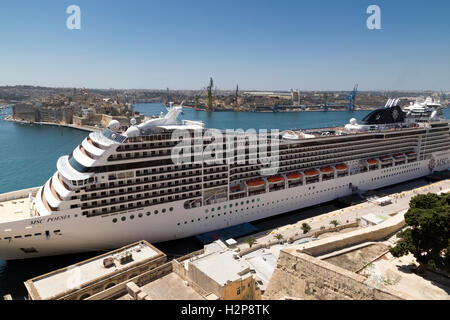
390 193 450 272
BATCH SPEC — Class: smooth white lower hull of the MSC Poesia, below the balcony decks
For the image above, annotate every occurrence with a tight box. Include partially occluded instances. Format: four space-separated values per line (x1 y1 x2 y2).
0 156 442 260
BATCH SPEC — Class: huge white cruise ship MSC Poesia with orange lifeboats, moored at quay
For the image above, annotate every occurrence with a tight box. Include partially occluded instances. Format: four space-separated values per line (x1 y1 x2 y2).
0 101 450 260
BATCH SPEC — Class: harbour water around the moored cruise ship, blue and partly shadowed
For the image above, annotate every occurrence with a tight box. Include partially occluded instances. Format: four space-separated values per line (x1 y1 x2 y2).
0 103 450 299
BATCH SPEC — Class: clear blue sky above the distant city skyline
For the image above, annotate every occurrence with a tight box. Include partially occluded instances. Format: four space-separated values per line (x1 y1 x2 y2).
0 0 450 90
